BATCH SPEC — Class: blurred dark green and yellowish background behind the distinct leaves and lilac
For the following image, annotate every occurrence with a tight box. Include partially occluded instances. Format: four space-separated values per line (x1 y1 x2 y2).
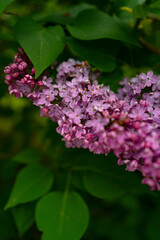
0 0 160 240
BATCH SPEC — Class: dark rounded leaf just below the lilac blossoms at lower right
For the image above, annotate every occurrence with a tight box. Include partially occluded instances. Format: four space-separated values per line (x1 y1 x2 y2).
84 157 126 199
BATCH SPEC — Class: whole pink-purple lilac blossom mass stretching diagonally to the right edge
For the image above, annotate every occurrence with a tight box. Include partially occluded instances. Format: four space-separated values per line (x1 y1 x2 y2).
4 50 160 190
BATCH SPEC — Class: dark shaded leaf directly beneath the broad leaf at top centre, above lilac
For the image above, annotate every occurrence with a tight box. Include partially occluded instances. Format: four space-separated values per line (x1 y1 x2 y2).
67 38 116 72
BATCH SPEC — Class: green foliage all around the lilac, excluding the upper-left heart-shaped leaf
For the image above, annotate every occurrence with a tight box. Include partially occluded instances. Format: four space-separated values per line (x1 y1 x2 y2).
0 0 160 240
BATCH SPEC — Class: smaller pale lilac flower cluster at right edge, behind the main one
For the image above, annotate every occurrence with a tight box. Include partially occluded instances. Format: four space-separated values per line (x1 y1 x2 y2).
117 71 160 128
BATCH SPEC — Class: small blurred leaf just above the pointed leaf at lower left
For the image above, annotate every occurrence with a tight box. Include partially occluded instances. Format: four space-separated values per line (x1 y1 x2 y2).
13 147 42 164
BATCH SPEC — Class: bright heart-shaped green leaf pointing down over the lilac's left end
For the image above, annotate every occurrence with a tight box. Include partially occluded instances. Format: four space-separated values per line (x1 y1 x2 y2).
14 18 65 78
